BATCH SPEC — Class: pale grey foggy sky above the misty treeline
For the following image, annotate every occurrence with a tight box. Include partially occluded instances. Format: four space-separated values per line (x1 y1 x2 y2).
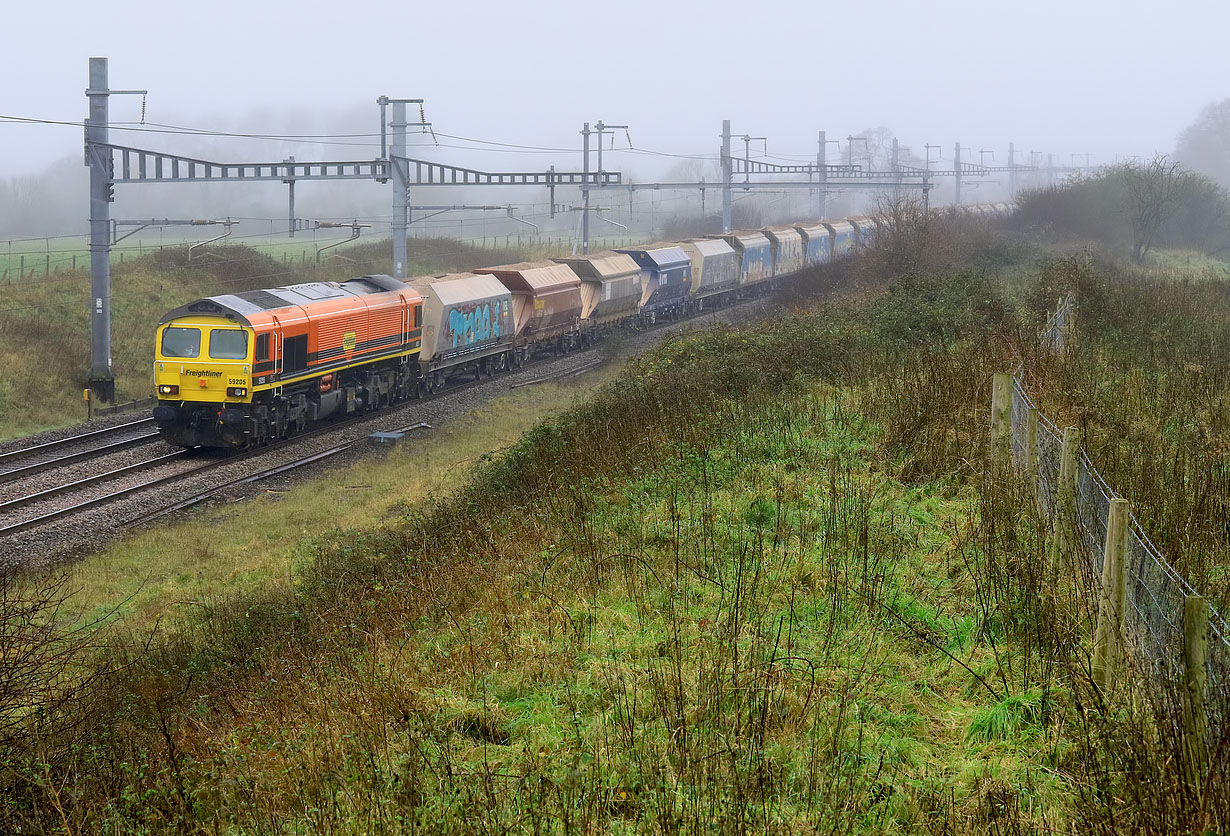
0 0 1230 176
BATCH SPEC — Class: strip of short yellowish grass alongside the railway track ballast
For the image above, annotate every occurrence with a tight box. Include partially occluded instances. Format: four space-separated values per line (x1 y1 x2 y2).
66 368 614 631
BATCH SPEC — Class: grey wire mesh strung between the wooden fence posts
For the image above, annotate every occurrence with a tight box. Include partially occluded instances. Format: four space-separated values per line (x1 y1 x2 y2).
1011 295 1230 734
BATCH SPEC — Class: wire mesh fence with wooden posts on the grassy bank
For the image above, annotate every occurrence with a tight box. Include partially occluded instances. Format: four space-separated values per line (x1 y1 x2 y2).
991 295 1230 745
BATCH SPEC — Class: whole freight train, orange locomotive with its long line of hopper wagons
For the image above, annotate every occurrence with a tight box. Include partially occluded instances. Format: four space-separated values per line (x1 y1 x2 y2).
154 204 1010 449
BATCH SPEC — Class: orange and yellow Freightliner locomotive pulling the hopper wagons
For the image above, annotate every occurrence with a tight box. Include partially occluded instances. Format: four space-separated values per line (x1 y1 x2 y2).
154 275 423 448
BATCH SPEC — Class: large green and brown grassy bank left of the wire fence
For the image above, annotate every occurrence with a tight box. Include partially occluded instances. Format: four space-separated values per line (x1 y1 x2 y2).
62 386 1070 832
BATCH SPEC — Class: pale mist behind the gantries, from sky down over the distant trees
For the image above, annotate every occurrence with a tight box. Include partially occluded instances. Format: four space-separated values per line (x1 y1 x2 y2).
0 0 1230 244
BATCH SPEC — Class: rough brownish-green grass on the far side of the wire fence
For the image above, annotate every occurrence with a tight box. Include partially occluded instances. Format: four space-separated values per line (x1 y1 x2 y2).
1027 257 1230 610
